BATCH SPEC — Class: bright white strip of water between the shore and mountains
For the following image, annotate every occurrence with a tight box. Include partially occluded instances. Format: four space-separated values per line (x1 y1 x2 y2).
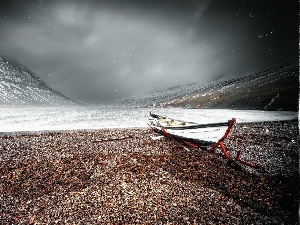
0 106 298 132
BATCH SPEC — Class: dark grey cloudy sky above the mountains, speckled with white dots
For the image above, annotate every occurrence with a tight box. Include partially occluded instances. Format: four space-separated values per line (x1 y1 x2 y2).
0 0 299 103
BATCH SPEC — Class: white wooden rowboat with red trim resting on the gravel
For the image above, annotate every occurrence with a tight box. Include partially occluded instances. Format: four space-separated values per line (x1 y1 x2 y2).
149 112 263 169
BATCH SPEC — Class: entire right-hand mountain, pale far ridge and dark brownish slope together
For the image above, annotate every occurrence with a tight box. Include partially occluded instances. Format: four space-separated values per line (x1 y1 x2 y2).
112 62 299 111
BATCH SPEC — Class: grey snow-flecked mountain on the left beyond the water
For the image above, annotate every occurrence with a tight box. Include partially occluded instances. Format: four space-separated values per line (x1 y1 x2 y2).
0 57 78 106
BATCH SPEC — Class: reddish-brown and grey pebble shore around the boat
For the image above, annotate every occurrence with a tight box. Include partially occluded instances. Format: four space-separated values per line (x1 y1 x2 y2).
0 120 299 224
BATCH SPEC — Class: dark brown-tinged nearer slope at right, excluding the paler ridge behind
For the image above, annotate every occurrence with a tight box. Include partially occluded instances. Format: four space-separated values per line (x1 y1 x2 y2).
164 64 299 111
